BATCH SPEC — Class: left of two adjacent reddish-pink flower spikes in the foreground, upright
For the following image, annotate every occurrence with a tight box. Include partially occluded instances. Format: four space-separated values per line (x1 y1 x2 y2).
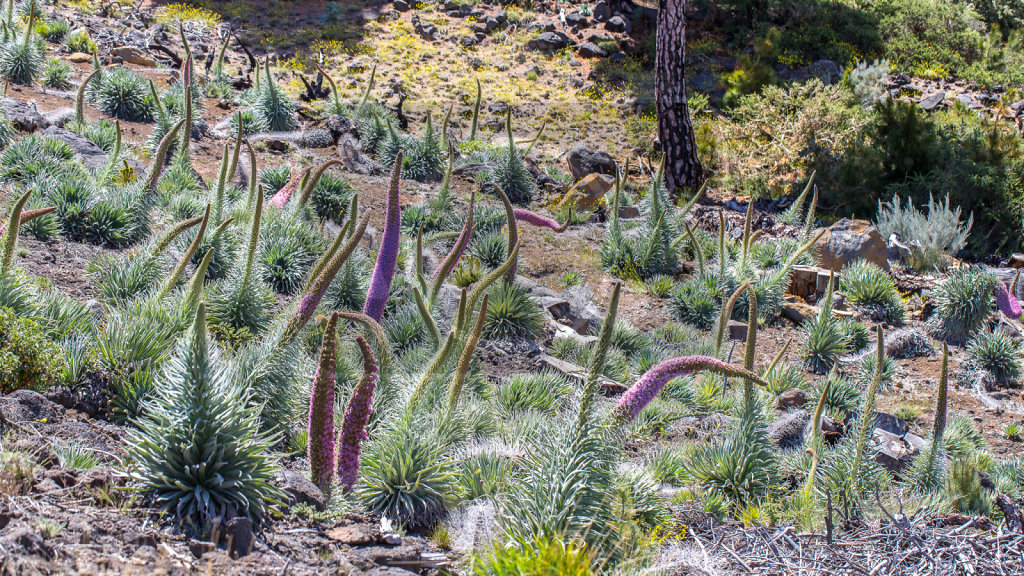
306 313 338 497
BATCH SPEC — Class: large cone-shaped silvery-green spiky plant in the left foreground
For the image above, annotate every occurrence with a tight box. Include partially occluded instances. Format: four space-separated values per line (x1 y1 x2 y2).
129 304 281 527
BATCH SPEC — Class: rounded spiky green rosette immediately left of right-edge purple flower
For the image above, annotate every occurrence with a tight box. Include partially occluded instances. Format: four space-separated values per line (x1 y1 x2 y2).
928 268 995 343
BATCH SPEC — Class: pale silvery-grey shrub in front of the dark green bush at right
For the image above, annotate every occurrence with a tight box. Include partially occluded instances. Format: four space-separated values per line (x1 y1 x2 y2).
876 195 974 271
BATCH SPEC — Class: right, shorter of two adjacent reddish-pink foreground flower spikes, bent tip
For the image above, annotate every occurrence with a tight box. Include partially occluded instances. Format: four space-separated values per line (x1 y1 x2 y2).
338 336 377 492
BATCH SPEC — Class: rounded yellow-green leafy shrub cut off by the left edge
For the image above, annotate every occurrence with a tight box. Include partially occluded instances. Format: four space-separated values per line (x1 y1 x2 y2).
0 307 63 394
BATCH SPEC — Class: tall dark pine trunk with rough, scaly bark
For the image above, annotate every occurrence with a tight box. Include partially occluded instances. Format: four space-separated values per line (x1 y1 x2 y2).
654 0 705 193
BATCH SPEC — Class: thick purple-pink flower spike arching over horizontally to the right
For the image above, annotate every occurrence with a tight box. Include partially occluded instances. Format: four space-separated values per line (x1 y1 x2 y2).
612 356 766 422
